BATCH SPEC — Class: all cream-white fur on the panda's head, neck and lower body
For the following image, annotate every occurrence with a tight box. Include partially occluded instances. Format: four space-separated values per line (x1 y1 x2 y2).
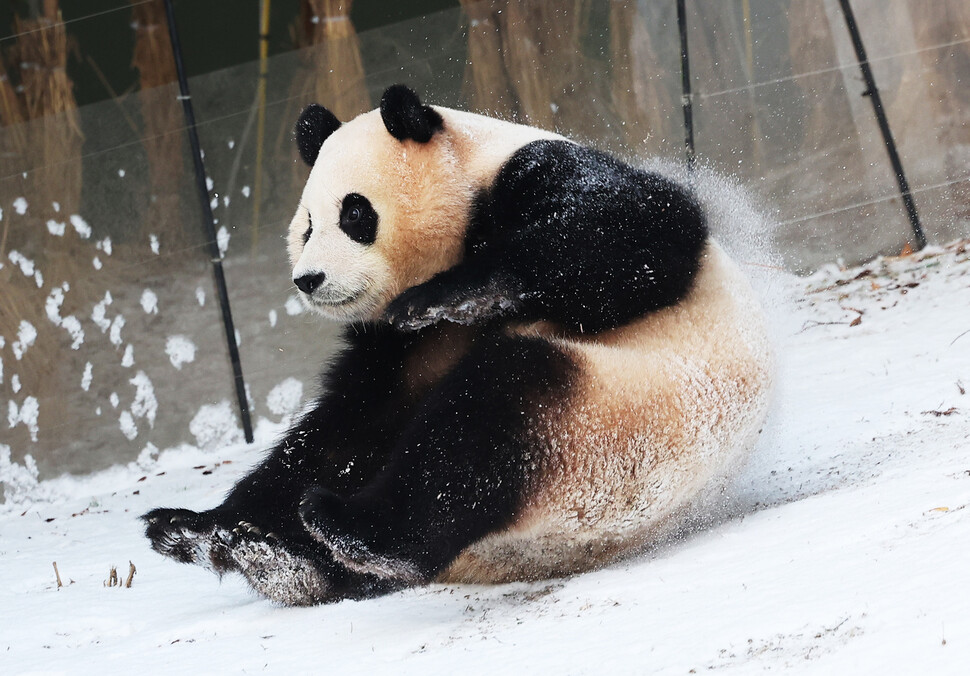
289 106 770 582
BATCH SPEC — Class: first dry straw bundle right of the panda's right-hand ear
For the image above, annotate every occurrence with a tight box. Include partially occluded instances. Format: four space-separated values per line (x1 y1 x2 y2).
461 0 518 120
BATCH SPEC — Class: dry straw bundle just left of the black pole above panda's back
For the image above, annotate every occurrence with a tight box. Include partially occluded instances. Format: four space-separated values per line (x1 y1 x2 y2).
610 0 674 154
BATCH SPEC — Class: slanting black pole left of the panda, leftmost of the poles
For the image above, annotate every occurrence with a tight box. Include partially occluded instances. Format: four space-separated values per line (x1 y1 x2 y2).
165 0 253 444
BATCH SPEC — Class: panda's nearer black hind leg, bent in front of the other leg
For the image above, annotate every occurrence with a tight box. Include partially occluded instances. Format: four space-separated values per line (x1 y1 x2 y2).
299 335 576 584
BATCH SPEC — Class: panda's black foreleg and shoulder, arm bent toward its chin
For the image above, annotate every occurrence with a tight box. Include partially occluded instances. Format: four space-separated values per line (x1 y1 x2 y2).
386 141 707 332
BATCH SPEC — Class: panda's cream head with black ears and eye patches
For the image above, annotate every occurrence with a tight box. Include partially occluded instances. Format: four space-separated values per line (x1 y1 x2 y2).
288 85 472 321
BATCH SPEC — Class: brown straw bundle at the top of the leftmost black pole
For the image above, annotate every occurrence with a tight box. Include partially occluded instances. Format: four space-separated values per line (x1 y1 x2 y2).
131 0 187 246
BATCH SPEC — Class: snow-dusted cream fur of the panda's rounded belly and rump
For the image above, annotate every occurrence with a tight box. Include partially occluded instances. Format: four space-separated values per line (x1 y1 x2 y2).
439 243 771 583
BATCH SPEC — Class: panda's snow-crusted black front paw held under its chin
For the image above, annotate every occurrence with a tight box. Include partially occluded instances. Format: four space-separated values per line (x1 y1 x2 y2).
384 273 519 331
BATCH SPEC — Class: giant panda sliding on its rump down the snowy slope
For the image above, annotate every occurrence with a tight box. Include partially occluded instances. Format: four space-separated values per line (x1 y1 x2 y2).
143 85 770 605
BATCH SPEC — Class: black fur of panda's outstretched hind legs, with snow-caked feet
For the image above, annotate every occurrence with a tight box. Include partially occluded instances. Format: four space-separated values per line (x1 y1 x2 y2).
142 326 574 605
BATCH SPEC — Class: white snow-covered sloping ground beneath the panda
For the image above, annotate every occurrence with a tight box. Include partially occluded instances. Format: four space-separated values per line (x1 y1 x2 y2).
0 242 970 674
